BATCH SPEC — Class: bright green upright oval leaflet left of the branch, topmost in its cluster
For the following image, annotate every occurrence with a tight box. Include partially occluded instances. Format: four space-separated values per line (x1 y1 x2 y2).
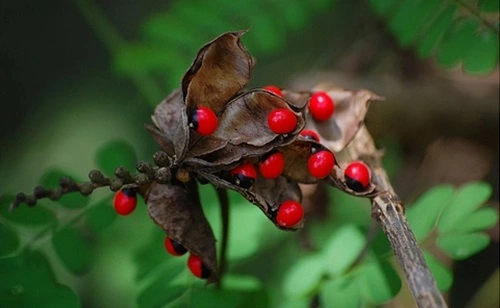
322 225 366 276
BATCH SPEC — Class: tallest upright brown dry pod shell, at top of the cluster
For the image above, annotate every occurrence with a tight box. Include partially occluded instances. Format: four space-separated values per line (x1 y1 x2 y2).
182 31 252 114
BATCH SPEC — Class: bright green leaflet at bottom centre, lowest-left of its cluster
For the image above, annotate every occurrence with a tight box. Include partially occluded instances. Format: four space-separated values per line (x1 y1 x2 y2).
283 254 326 298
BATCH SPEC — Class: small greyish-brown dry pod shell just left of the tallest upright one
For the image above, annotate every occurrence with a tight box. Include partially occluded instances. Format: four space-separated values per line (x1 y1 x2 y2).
146 89 189 160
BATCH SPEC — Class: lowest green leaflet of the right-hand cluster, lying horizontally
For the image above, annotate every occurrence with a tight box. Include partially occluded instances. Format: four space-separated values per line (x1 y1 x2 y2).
437 233 490 260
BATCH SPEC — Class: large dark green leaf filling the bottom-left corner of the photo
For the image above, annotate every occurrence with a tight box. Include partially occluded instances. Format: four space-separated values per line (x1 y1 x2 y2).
0 251 80 308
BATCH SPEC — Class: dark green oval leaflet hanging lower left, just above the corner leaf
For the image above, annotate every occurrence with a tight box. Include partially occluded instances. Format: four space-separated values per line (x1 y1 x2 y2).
52 227 91 276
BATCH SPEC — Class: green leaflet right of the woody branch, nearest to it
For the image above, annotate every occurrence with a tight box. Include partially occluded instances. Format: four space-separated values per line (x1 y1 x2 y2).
406 185 455 241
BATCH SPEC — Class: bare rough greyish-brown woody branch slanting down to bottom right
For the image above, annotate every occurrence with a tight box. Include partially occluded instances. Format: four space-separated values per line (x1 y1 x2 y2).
346 126 447 307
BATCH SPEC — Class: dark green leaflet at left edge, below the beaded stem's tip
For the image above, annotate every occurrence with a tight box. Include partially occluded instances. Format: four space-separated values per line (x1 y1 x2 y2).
0 196 55 226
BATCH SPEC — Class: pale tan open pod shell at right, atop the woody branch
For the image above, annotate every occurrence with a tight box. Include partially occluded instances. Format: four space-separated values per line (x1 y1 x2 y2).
306 83 383 152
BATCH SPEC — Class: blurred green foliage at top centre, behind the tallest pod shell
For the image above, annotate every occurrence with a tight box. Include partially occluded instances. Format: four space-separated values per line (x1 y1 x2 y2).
113 0 335 100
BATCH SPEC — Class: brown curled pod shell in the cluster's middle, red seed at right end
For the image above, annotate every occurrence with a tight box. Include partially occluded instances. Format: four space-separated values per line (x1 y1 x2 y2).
185 90 305 166
